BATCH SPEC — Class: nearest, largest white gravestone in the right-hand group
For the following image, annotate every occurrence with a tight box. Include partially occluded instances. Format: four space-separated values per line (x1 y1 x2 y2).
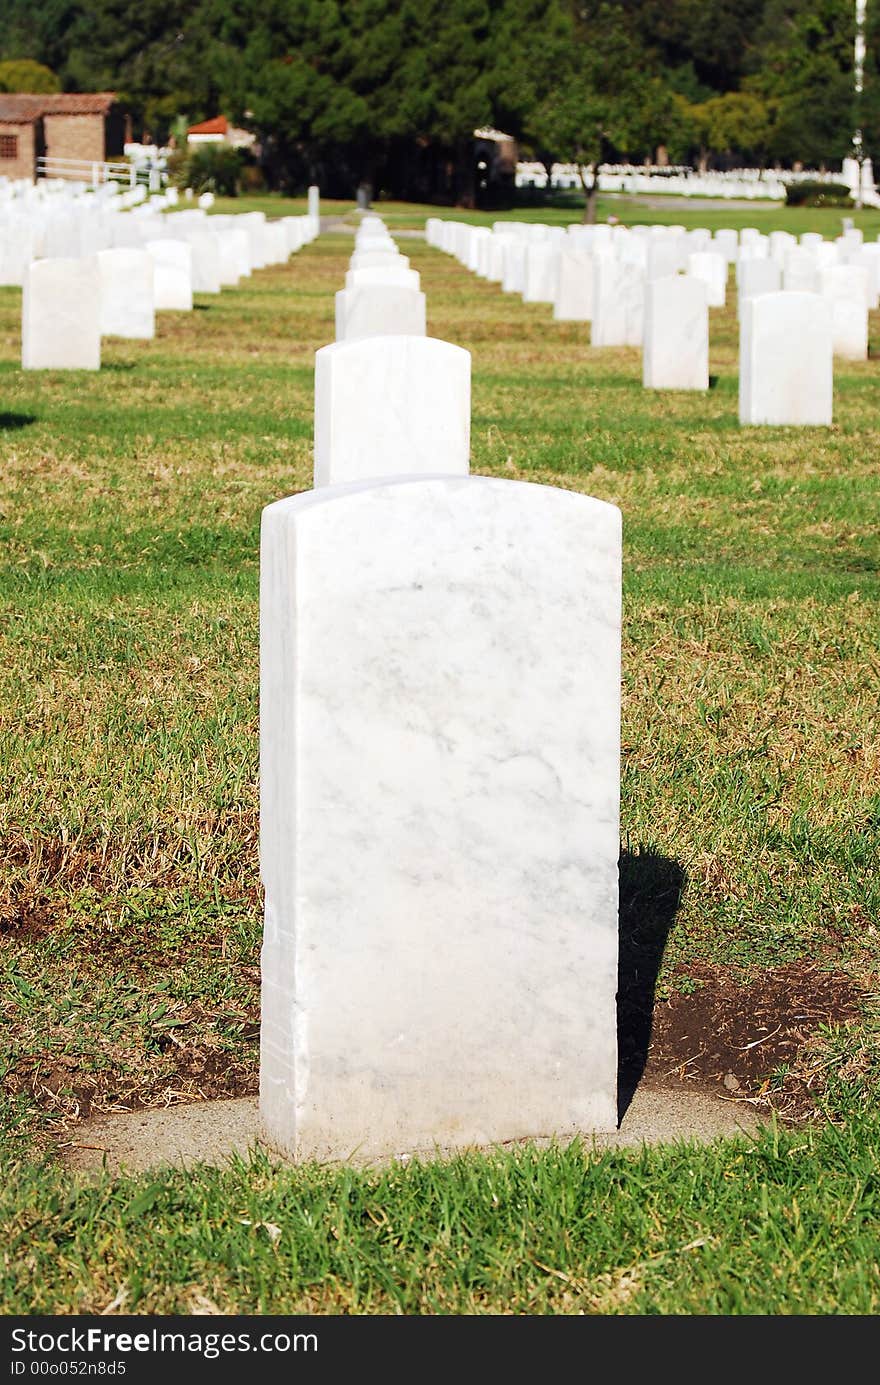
740 291 833 425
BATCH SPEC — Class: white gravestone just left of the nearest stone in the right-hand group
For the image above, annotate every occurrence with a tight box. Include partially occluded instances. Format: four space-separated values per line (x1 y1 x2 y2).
642 274 710 389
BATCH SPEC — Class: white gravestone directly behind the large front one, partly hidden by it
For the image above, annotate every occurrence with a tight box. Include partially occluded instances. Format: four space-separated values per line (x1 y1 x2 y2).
315 337 471 488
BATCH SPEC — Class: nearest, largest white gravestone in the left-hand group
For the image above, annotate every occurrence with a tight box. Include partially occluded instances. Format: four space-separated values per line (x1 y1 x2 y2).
21 256 101 370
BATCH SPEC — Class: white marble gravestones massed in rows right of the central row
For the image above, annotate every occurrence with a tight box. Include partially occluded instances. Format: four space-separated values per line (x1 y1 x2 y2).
425 217 880 424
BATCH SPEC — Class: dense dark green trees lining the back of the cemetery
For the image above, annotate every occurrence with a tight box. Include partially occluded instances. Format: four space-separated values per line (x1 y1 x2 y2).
0 0 880 201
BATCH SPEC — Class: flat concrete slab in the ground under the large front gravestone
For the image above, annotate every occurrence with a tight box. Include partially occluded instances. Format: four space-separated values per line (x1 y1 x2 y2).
60 1087 762 1176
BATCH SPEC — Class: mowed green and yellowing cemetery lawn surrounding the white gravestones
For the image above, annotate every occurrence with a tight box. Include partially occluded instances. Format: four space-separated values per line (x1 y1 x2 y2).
0 224 880 1313
